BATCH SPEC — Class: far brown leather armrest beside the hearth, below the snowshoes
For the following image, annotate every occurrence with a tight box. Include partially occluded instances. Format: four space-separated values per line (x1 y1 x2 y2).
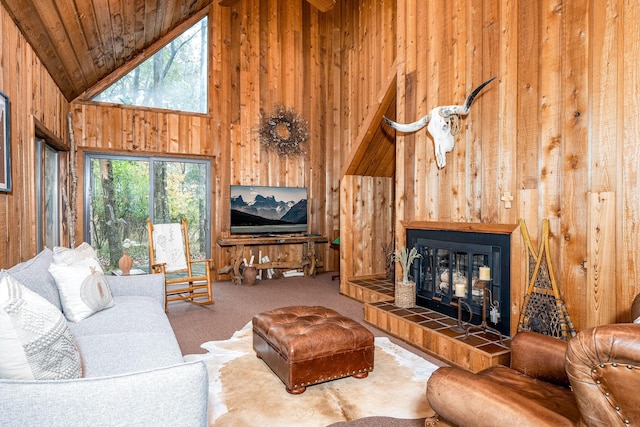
511 331 569 386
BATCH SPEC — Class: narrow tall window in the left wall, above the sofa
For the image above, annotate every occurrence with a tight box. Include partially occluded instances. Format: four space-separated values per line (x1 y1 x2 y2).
36 137 62 252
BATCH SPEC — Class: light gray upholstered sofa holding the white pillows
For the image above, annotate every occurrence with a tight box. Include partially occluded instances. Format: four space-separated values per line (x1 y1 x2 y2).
0 249 208 426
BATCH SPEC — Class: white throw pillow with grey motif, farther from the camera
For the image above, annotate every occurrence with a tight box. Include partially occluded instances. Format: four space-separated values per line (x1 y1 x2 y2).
49 243 113 322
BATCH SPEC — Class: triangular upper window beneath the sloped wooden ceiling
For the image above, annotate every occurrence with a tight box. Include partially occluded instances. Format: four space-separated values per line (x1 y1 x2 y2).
93 17 209 113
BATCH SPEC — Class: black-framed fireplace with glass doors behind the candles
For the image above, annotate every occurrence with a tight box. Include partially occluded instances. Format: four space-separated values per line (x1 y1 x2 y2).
406 228 511 336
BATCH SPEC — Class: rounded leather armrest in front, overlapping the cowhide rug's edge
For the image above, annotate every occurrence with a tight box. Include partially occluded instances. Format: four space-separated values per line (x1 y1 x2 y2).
427 367 573 427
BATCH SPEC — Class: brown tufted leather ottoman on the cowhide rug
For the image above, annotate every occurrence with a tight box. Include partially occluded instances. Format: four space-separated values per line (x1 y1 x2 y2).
252 306 375 394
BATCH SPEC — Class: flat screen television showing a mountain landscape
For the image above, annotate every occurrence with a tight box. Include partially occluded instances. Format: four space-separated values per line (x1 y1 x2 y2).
231 185 308 235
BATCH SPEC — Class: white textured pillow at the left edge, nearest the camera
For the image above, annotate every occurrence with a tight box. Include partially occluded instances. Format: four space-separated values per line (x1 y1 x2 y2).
0 274 82 380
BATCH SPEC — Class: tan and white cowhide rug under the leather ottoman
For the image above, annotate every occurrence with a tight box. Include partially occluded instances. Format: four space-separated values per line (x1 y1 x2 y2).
185 324 437 427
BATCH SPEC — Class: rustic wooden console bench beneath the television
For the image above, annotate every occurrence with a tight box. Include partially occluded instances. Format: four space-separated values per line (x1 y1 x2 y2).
217 235 327 285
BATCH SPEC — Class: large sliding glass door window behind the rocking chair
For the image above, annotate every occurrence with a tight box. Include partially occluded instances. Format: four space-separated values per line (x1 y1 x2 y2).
84 154 211 271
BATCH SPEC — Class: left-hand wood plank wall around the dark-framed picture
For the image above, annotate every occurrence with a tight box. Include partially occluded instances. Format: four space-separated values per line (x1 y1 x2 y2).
0 6 69 268
